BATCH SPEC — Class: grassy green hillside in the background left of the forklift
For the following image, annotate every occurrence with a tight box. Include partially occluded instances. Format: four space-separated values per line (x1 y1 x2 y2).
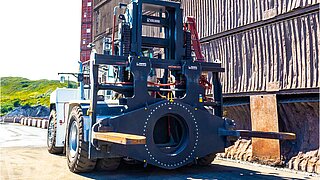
0 77 77 116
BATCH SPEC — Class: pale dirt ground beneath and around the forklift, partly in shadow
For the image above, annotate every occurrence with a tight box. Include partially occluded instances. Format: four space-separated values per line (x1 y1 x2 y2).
0 124 319 180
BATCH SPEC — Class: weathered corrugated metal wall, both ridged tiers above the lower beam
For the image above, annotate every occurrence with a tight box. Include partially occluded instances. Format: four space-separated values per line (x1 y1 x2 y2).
182 0 320 94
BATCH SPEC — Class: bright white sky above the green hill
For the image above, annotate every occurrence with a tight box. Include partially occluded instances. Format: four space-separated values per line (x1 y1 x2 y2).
0 0 81 80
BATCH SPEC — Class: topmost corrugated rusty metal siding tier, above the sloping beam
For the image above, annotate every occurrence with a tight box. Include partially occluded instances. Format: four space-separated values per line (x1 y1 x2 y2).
181 0 320 38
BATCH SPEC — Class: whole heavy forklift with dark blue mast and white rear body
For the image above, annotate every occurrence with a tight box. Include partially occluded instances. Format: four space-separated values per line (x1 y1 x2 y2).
48 0 293 173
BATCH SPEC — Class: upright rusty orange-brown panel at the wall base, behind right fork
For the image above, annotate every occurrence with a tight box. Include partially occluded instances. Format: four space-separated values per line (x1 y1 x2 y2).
250 95 280 162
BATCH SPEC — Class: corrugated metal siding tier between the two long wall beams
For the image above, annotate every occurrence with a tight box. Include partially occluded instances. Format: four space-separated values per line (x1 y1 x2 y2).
202 12 320 93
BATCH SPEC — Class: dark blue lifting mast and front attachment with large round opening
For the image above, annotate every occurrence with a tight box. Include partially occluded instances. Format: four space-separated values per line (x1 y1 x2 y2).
67 0 230 172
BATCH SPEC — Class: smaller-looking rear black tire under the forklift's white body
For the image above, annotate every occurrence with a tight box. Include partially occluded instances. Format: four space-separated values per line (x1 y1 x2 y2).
47 109 63 154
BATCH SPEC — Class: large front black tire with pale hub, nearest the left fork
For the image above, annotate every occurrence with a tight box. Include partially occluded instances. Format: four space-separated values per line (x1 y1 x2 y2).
66 106 96 173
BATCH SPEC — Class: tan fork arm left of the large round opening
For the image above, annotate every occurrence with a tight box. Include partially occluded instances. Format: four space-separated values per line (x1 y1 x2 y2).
92 132 146 145
